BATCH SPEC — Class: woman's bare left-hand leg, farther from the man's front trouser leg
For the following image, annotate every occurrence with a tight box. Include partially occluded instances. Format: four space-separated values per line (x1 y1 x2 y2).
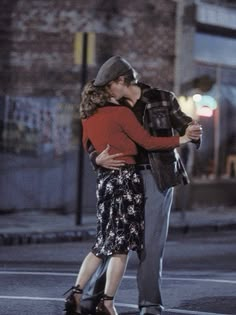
75 252 102 313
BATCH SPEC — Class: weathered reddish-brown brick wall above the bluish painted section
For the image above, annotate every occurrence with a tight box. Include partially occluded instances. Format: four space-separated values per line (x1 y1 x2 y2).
0 0 176 102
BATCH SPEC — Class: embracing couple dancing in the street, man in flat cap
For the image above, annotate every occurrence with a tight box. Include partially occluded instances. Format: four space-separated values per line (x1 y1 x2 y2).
65 56 202 315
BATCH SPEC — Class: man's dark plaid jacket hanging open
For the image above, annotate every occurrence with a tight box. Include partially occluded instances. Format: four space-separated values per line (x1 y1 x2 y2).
139 83 200 191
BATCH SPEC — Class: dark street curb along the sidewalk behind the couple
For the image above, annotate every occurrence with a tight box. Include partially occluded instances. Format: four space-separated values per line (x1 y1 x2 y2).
0 223 236 246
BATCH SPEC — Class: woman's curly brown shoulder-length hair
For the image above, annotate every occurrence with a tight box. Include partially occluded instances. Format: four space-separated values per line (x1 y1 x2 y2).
80 80 111 119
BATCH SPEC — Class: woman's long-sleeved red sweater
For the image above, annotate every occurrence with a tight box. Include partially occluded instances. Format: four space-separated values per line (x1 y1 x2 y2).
82 105 179 164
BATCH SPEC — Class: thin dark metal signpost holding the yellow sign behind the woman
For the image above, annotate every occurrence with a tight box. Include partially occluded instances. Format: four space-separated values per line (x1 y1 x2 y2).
76 33 88 225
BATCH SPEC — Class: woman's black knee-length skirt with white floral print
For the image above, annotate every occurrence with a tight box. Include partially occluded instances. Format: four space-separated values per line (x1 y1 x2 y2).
92 165 144 258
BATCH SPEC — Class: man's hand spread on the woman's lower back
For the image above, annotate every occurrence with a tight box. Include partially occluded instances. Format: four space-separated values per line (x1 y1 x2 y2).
96 144 125 170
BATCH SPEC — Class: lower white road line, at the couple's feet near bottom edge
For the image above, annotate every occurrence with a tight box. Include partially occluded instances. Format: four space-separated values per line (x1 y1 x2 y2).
0 295 225 315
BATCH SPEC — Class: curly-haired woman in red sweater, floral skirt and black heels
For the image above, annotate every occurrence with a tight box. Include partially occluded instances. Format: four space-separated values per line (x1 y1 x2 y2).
63 82 190 315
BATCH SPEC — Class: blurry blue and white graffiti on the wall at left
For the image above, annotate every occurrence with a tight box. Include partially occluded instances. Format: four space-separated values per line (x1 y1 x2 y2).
0 96 77 156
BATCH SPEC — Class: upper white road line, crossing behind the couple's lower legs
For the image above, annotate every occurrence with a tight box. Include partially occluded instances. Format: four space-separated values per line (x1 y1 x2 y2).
0 271 236 284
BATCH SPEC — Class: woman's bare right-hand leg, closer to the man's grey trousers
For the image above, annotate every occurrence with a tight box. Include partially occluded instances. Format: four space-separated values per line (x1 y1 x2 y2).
104 254 128 315
